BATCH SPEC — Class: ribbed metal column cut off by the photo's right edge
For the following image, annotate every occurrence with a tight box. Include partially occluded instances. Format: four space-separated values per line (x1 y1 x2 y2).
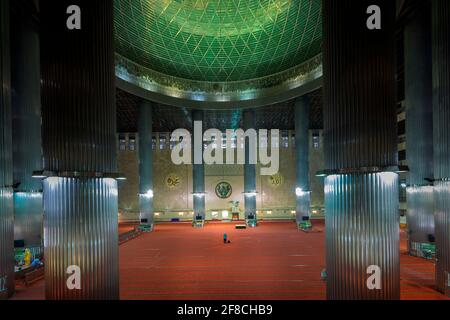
432 0 450 295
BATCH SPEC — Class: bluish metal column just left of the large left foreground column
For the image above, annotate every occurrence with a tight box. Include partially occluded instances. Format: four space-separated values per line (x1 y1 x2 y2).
11 1 43 246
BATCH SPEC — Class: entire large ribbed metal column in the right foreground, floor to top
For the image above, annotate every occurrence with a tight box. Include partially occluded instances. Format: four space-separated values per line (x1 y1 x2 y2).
323 0 400 299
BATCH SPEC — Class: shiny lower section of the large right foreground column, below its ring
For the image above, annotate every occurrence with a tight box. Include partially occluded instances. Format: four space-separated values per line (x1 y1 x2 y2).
325 172 400 300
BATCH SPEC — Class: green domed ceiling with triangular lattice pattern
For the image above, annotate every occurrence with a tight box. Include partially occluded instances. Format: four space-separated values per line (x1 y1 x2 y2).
115 0 322 82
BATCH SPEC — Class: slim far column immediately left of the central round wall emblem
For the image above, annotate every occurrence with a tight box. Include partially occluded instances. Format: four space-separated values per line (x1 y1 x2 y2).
192 110 206 220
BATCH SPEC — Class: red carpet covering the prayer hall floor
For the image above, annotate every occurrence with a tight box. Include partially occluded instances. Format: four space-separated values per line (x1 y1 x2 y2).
10 221 445 300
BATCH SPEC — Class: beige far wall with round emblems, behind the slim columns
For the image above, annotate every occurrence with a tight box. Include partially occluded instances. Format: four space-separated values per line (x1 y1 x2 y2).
118 132 324 221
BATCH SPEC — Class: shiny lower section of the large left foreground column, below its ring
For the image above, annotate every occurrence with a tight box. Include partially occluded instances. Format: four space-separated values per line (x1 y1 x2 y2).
44 177 119 300
